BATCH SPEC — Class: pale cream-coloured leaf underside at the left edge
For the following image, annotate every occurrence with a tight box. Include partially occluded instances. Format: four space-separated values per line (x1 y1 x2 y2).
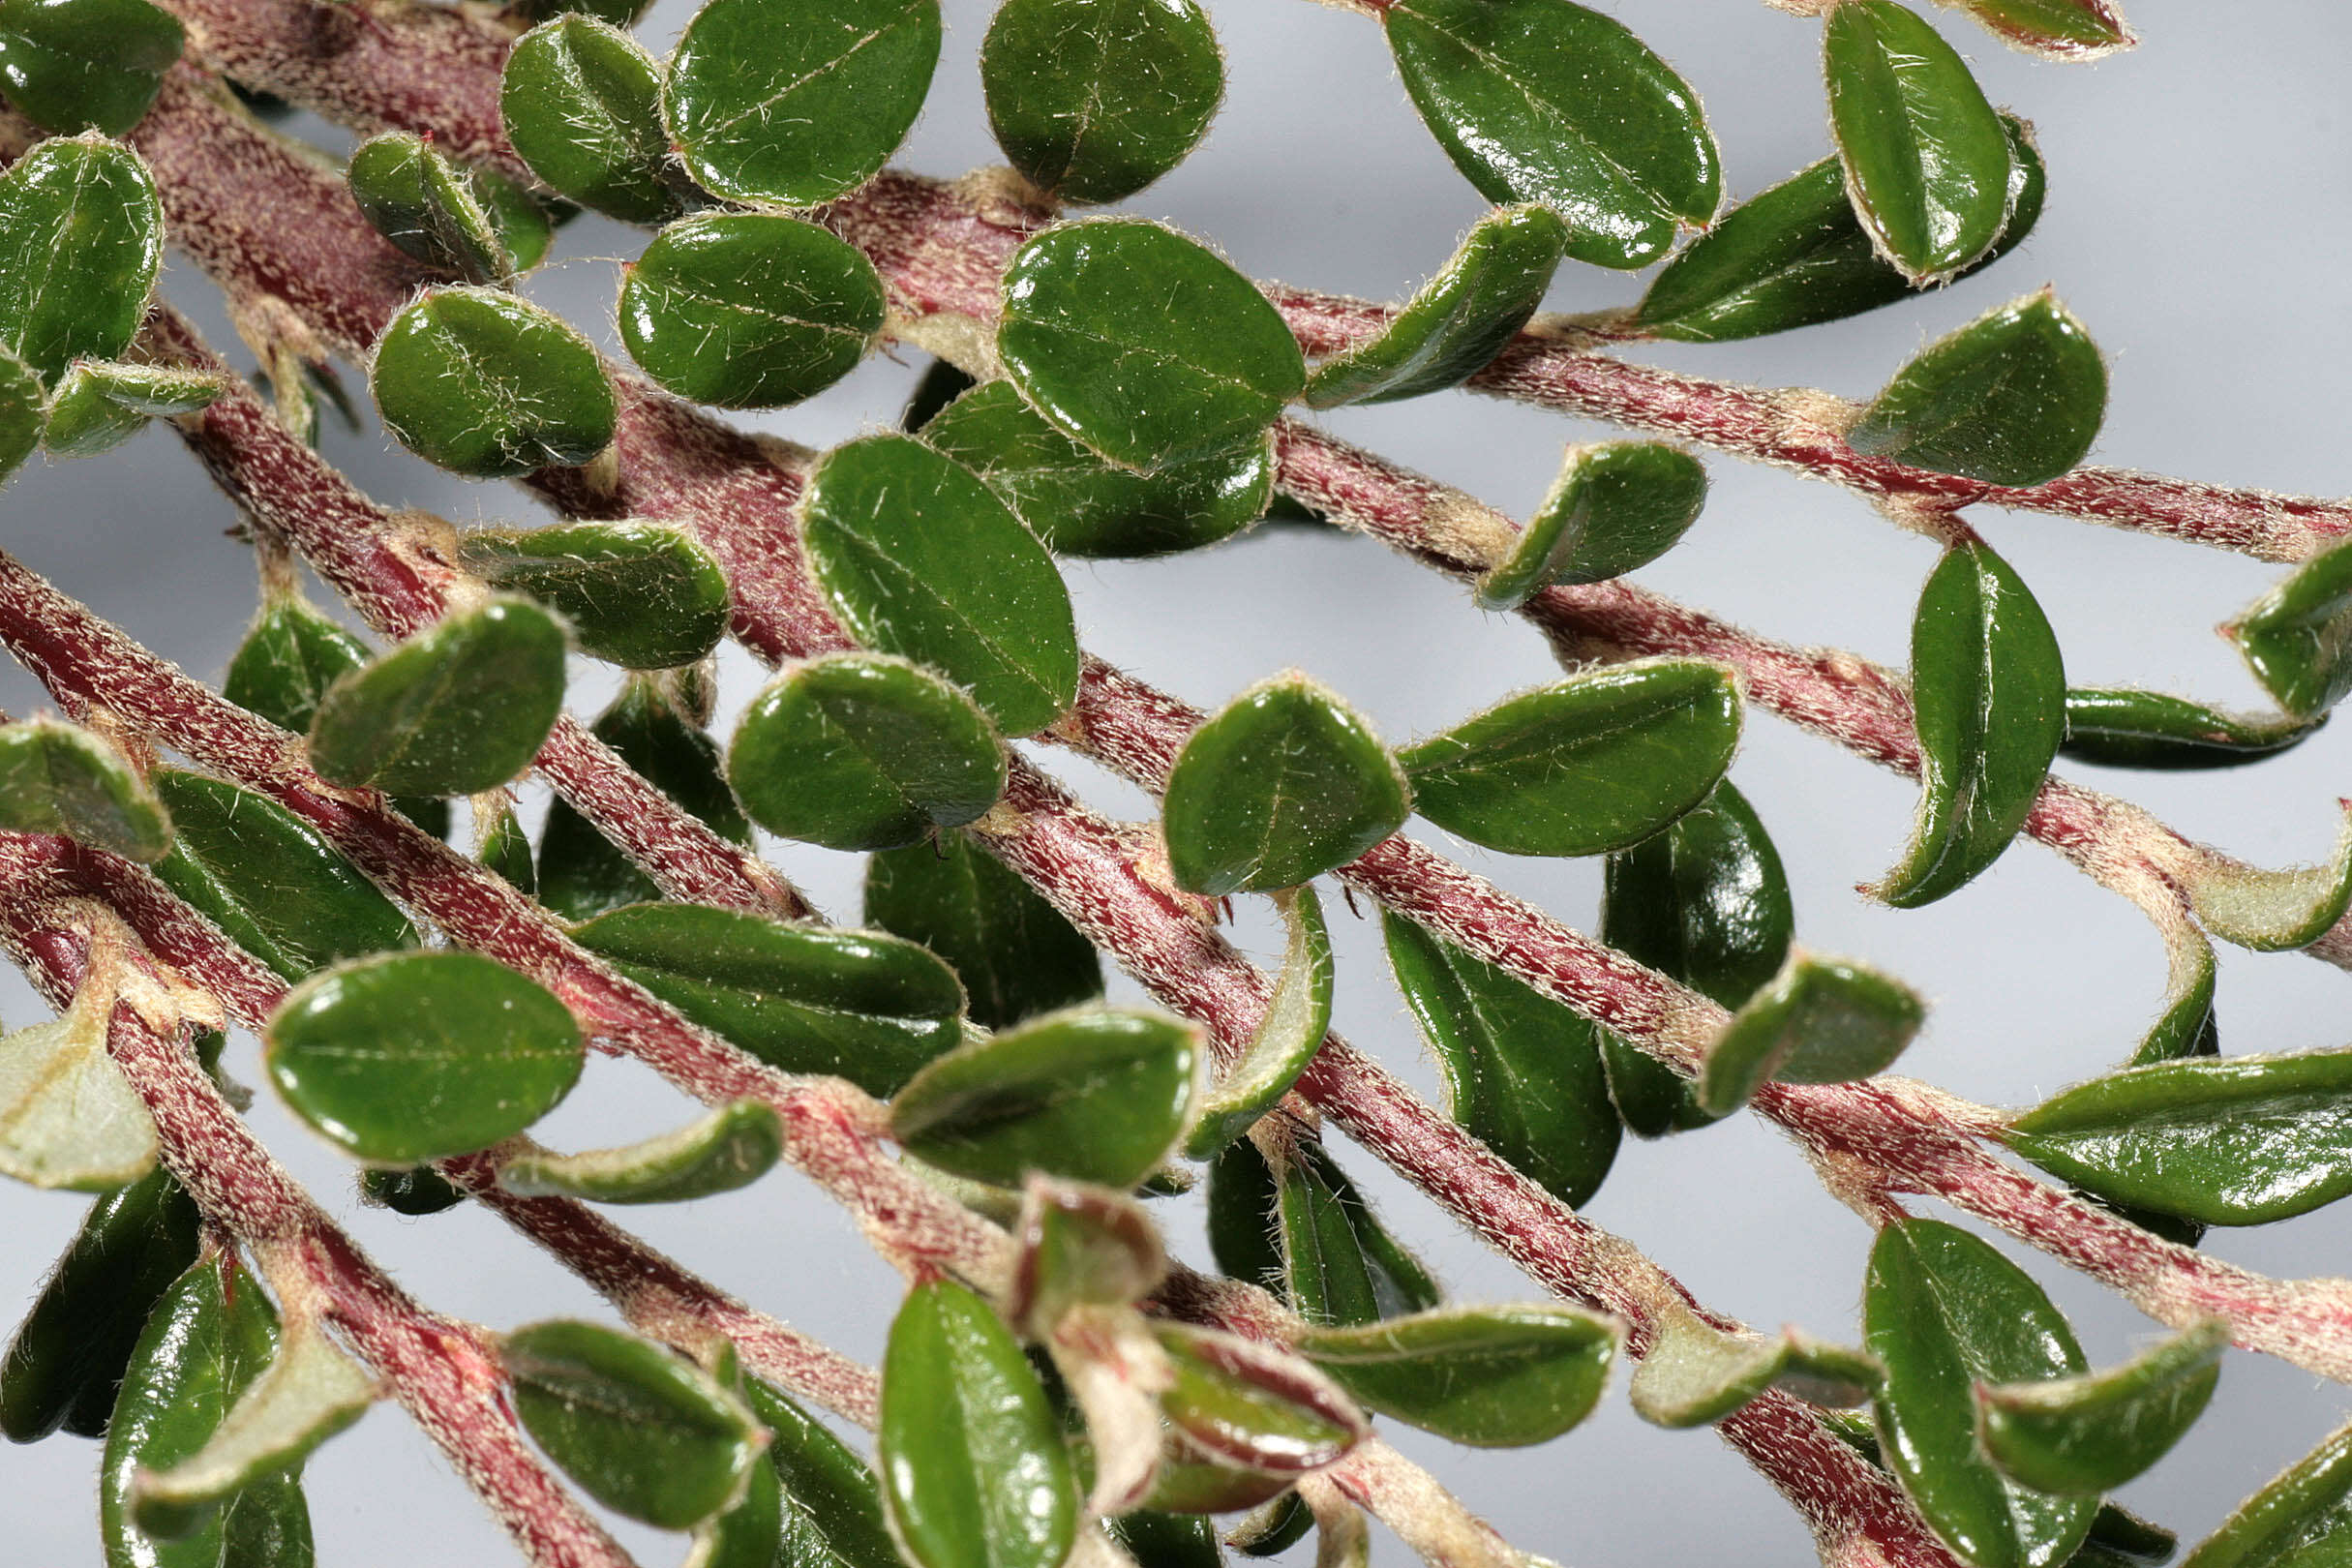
0 999 155 1191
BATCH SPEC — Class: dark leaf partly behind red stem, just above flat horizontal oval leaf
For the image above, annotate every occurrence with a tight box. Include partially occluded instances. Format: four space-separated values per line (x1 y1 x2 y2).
151 769 416 982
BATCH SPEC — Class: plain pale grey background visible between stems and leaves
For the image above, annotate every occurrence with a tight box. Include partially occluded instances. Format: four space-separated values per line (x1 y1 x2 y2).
0 0 2352 1568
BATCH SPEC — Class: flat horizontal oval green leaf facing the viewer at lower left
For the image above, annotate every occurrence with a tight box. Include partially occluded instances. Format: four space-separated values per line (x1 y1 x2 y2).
263 950 584 1163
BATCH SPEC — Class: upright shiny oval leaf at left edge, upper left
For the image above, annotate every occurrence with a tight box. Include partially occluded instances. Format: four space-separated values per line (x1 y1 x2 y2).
0 133 163 380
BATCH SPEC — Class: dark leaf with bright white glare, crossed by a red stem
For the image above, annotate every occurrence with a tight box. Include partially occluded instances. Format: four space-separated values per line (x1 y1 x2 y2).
1599 778 1794 1138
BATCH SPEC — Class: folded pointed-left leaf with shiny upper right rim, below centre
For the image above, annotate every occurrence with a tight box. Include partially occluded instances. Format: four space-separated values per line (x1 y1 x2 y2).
891 1009 1204 1188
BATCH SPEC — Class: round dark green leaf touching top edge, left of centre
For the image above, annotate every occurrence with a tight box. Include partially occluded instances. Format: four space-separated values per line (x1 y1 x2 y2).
980 0 1225 202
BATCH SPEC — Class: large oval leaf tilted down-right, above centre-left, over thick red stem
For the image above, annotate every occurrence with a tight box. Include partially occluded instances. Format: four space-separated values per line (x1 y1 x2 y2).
802 435 1077 738
